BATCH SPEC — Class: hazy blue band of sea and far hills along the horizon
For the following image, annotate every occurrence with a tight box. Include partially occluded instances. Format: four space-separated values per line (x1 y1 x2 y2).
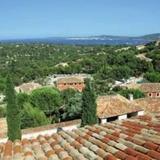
0 33 160 45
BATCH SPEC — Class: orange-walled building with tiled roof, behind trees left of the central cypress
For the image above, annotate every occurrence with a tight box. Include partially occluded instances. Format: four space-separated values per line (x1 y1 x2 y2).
56 76 85 92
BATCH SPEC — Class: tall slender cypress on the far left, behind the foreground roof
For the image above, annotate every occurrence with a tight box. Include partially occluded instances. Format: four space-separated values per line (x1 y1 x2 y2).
6 75 21 141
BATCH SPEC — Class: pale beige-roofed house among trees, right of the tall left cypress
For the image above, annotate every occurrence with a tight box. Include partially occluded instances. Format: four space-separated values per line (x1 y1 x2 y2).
15 82 42 93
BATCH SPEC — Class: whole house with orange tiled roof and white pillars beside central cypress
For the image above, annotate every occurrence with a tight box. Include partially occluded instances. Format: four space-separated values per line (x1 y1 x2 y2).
97 94 143 123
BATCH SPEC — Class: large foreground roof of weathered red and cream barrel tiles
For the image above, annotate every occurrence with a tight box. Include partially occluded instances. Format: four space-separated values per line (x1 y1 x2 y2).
0 114 160 160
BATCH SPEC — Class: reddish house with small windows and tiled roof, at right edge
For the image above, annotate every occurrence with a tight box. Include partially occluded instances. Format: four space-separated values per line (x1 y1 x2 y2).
139 83 160 98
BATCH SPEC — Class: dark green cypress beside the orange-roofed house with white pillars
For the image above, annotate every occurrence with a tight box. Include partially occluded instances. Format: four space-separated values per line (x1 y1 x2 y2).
81 79 98 127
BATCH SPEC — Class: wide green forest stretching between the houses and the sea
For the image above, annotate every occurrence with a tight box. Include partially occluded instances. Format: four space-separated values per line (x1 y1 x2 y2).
0 42 160 92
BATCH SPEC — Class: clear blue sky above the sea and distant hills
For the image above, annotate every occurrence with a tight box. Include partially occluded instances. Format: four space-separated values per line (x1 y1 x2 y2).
0 0 160 39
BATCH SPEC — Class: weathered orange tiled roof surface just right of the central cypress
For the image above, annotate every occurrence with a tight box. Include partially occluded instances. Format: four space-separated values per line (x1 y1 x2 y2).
97 95 141 118
